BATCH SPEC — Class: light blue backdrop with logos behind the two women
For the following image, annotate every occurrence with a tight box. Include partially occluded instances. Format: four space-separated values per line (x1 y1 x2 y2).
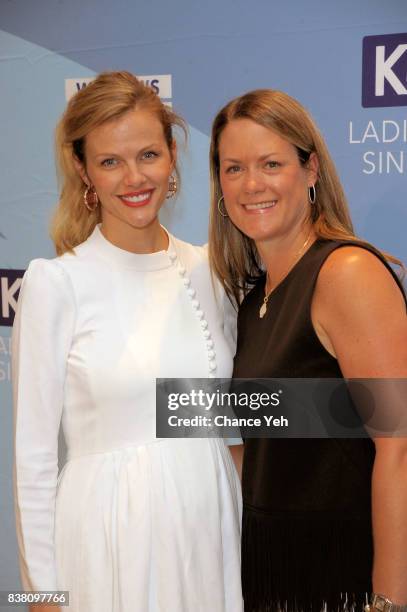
0 0 407 609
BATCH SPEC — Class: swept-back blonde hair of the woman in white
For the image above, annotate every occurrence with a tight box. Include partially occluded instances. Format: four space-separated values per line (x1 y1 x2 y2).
50 71 186 255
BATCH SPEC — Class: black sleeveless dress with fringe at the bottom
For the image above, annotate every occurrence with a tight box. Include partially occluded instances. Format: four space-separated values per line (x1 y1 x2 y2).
233 240 403 612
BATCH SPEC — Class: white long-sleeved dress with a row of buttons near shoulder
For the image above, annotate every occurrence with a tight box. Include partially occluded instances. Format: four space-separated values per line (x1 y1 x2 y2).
12 227 243 612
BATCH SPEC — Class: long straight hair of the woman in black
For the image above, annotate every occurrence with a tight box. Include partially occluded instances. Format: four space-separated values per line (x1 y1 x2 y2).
209 89 403 304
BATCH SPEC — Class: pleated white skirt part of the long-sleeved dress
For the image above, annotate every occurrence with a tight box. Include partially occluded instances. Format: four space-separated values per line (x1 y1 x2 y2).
55 439 243 612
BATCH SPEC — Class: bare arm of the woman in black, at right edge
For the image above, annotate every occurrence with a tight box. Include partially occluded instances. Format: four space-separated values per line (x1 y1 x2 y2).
312 246 407 604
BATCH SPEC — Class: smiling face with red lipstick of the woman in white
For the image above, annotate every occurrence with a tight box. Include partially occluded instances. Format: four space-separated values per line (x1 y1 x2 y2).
76 110 175 250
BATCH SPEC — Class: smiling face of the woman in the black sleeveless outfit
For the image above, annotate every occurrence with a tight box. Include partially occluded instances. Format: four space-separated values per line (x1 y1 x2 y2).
219 119 318 246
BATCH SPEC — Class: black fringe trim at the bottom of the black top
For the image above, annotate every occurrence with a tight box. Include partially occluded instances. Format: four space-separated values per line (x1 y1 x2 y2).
242 507 373 612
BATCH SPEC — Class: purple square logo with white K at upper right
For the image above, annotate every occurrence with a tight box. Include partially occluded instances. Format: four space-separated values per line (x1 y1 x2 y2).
362 34 407 108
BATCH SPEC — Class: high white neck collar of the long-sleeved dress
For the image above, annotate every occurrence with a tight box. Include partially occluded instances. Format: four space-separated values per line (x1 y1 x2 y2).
86 225 176 271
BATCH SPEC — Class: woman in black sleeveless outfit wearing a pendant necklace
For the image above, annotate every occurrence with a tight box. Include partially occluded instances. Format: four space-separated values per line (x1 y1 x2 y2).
210 90 407 612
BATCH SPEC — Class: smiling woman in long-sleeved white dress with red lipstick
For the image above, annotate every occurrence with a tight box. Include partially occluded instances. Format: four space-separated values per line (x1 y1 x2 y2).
13 72 242 612
